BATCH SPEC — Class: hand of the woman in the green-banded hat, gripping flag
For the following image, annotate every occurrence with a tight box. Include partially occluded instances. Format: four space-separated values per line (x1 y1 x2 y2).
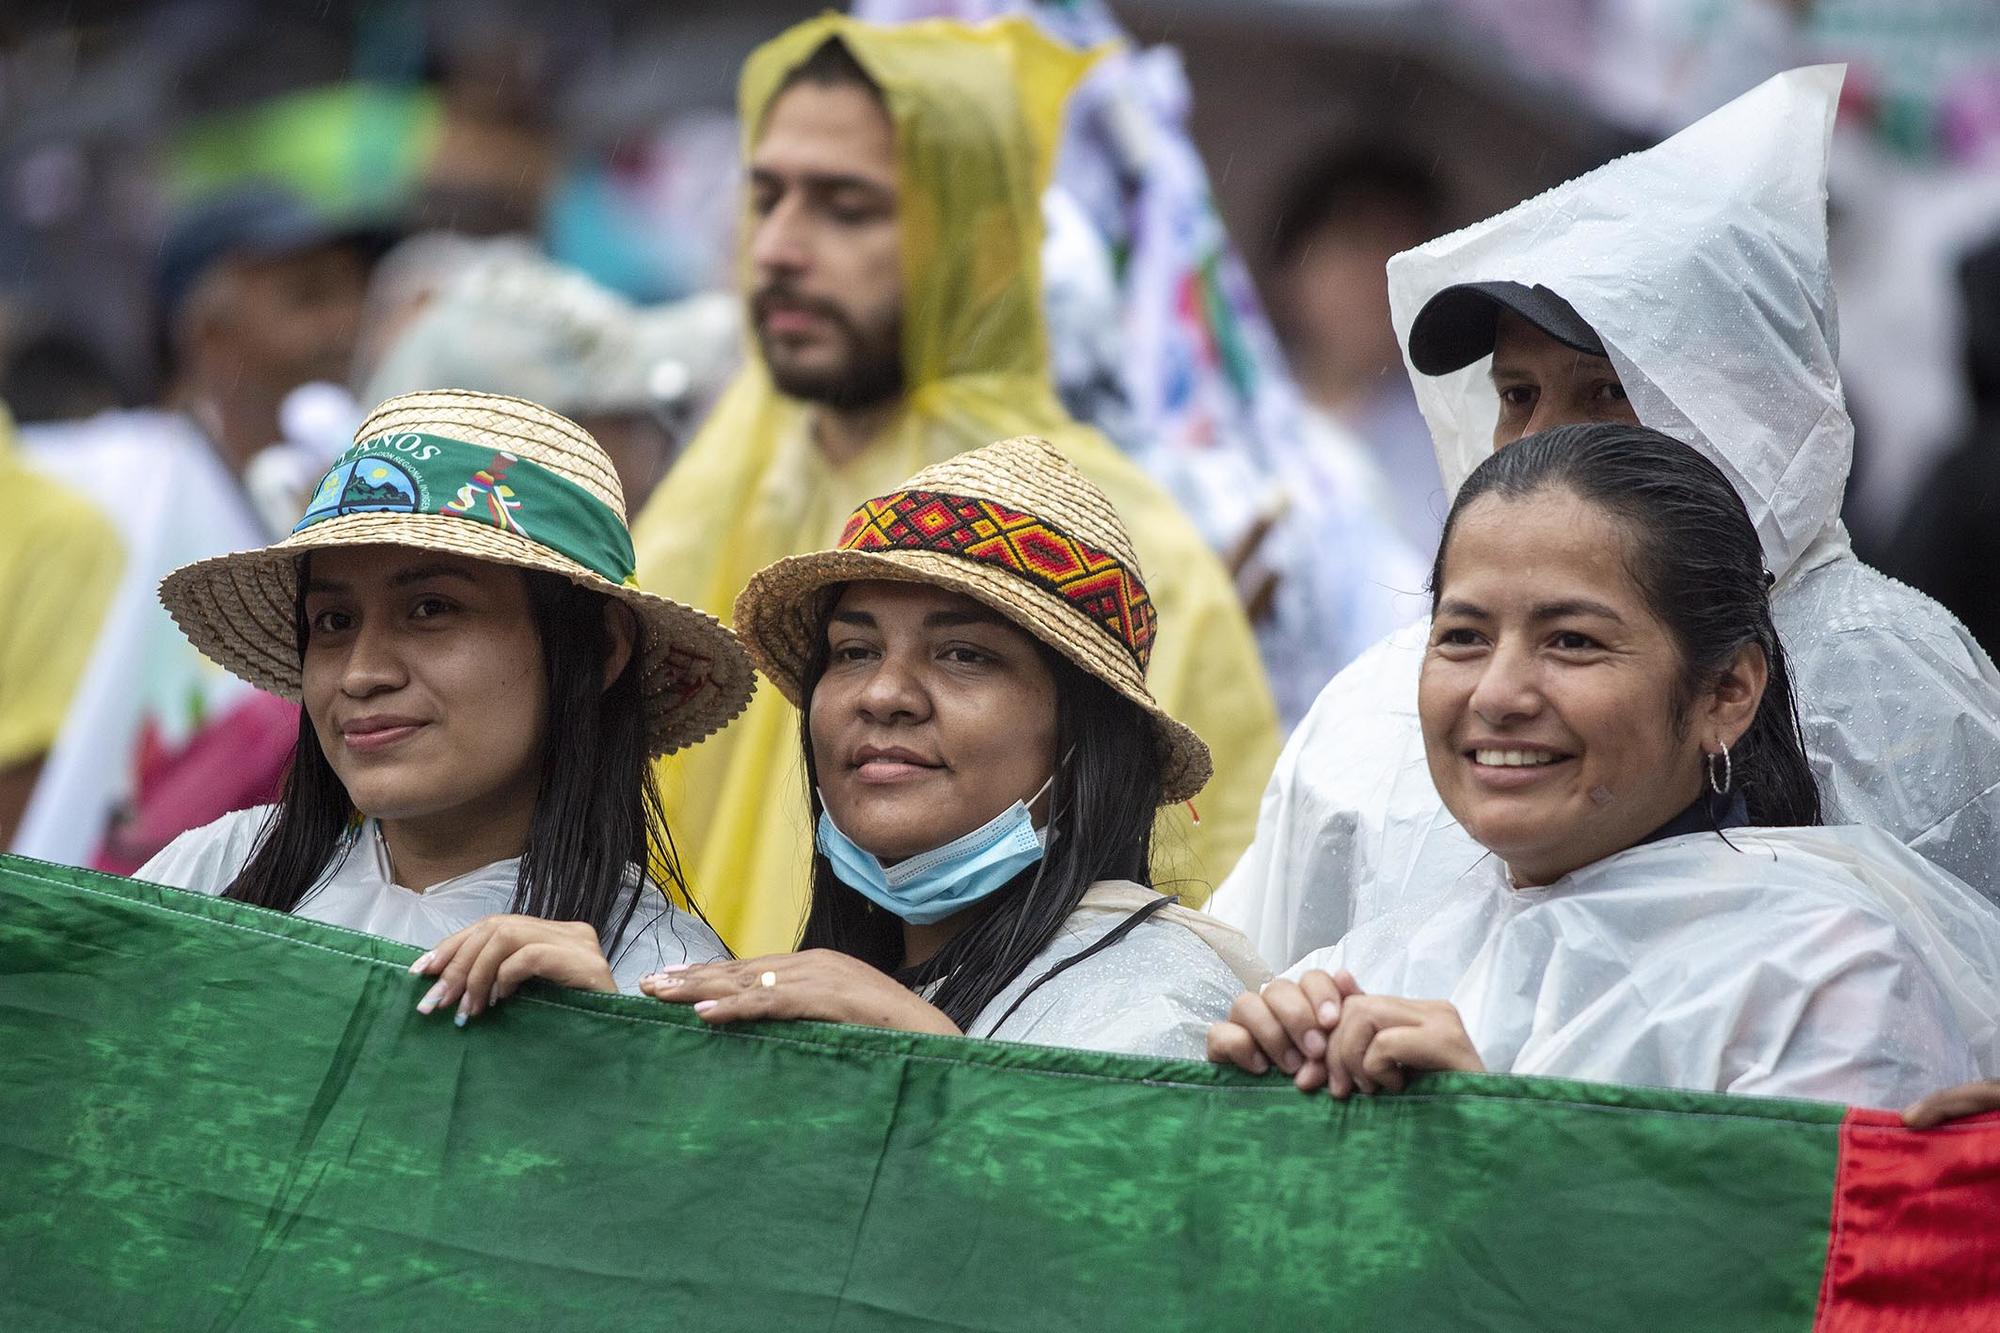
410 917 618 1027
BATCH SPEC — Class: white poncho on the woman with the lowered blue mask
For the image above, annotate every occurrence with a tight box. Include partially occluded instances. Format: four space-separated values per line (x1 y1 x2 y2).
966 881 1270 1061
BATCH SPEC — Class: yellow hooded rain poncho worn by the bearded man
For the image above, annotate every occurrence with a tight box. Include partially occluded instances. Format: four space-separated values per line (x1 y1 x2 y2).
634 14 1278 953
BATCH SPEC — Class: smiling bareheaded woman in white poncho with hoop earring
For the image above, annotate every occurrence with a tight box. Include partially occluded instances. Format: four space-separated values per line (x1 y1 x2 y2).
1210 422 2000 1107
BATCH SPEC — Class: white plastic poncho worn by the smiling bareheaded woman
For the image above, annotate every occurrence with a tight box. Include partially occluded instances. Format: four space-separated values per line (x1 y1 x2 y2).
1290 829 2000 1107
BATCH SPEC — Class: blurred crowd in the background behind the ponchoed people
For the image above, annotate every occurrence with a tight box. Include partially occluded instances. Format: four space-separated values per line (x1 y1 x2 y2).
0 0 2000 871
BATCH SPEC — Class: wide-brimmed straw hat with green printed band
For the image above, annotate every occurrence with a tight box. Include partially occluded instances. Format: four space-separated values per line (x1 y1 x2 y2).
160 390 756 755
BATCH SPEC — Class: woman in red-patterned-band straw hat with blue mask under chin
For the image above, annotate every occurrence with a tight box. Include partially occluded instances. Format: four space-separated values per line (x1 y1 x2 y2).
642 438 1268 1059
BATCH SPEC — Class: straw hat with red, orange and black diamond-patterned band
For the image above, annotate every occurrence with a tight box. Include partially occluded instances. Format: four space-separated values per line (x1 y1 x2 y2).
734 436 1214 805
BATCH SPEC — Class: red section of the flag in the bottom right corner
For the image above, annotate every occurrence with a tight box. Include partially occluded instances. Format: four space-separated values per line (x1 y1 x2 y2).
1812 1109 2000 1333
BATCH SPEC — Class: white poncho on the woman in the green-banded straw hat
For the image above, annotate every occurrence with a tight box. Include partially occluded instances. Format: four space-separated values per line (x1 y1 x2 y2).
132 805 730 995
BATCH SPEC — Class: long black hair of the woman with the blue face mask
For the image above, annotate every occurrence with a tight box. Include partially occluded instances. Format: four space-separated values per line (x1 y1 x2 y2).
798 624 1160 1031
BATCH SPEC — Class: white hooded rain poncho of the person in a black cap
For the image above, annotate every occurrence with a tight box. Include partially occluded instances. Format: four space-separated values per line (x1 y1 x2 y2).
1212 66 2000 963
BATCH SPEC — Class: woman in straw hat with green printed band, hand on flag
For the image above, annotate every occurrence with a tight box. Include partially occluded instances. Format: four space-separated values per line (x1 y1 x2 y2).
138 390 754 1023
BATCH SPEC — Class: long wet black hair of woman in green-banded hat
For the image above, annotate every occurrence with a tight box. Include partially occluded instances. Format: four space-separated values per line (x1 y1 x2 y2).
224 556 692 955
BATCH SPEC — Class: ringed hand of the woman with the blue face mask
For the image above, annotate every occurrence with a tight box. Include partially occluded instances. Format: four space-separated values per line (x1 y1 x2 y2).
640 949 960 1037
